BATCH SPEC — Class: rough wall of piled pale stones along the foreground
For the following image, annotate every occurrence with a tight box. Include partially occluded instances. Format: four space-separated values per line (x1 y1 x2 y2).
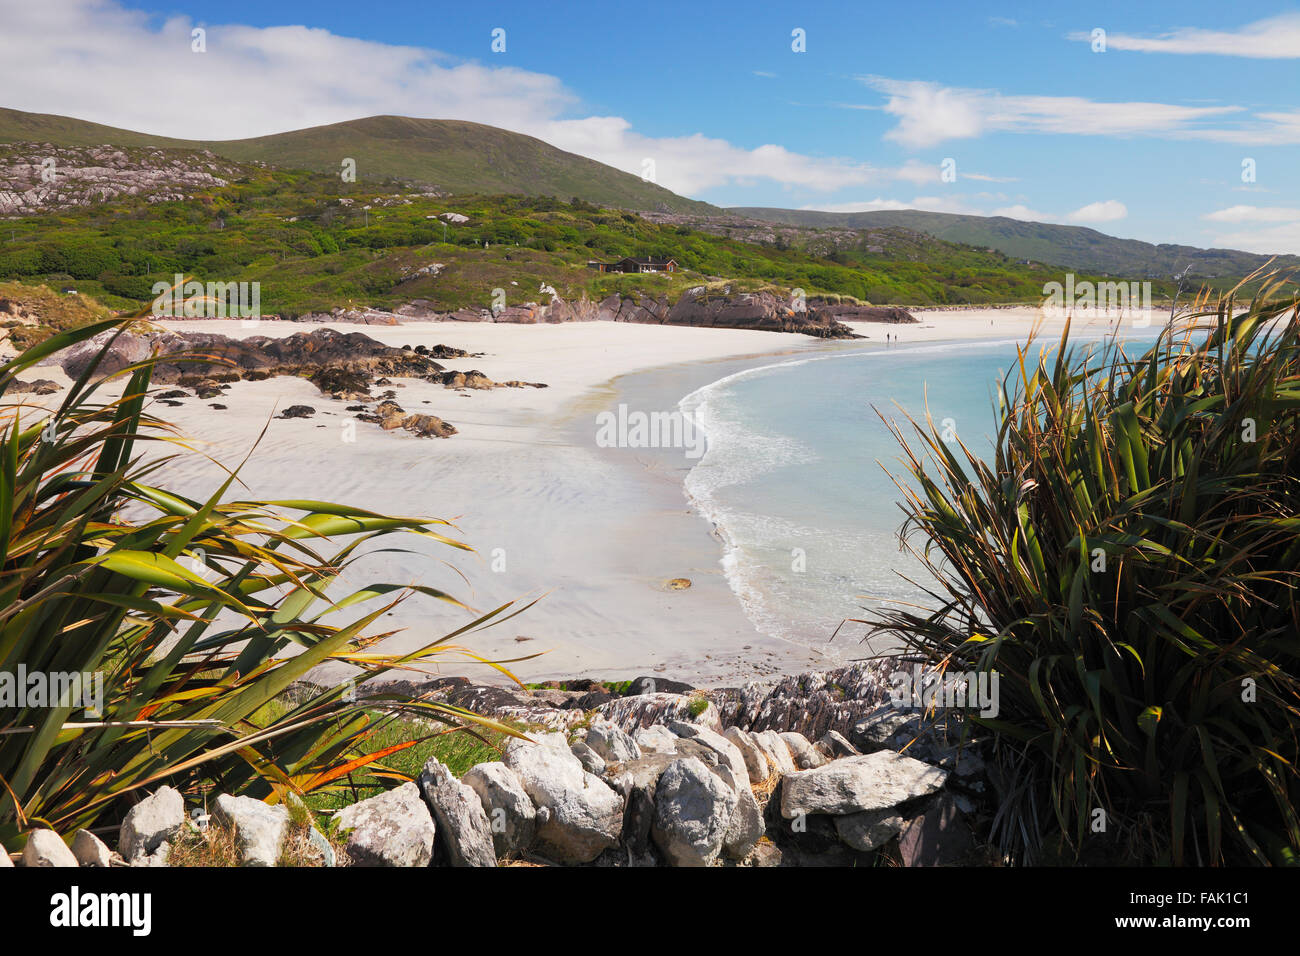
0 663 985 866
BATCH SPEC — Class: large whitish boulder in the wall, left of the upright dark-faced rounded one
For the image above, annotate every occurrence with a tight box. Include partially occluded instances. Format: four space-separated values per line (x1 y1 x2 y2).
504 734 623 864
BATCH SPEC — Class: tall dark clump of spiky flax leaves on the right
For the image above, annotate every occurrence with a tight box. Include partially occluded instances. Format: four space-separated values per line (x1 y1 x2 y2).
866 280 1300 865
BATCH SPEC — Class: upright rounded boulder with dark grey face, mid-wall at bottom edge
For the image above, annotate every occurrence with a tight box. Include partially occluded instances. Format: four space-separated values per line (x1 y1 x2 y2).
651 757 740 866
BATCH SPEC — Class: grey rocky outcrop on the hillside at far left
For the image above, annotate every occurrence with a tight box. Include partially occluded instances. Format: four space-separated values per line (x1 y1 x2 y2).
0 143 239 216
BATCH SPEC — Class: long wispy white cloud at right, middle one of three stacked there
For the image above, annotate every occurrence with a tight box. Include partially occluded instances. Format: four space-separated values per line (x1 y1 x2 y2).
861 77 1274 148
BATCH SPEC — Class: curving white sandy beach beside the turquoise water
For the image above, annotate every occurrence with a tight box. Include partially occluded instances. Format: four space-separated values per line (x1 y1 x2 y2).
25 308 1123 684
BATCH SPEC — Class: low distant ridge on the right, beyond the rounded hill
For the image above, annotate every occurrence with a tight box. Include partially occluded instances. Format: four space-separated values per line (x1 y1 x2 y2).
728 207 1300 278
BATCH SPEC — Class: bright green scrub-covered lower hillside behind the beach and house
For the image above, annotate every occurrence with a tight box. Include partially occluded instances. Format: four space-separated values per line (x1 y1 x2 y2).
0 153 1133 316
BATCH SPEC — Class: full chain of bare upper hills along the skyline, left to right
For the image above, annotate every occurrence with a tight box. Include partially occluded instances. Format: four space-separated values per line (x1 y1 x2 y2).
0 108 1300 280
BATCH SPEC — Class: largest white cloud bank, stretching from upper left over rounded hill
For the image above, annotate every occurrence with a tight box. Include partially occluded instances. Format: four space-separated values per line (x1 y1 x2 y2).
0 0 892 195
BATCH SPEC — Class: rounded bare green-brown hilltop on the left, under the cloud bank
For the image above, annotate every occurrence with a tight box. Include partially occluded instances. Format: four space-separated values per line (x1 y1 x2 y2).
0 108 716 213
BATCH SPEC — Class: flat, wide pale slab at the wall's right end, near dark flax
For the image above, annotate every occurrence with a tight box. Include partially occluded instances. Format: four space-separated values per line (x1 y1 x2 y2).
781 750 948 819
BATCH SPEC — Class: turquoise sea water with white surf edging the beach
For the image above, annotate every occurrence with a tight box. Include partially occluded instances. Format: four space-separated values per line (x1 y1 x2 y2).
680 330 1149 657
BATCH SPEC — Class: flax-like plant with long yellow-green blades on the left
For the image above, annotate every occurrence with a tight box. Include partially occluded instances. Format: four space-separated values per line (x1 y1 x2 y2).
0 319 533 847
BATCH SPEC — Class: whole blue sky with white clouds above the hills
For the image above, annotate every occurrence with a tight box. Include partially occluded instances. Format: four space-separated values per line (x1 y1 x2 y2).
0 0 1300 254
